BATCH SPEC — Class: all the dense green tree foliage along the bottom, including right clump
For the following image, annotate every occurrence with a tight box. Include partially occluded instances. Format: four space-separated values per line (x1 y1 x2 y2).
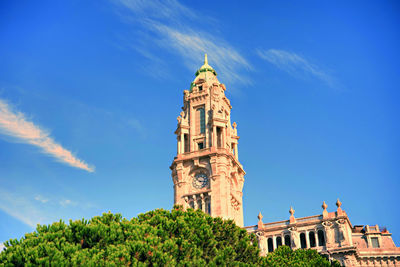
0 207 340 266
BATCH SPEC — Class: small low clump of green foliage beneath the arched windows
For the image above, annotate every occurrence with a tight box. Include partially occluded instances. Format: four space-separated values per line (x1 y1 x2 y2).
261 246 341 267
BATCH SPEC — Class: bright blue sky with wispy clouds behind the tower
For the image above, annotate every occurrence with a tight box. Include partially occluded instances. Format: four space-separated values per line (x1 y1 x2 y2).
0 0 400 244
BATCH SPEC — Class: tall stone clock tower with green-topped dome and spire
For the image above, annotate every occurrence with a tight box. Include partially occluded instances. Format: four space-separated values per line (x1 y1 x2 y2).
170 55 245 226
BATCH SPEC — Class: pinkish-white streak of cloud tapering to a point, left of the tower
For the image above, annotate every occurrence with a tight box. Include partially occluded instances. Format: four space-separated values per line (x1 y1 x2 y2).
0 99 94 172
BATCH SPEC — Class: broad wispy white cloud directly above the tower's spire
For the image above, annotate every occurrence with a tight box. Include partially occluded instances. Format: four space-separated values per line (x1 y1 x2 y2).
114 0 252 87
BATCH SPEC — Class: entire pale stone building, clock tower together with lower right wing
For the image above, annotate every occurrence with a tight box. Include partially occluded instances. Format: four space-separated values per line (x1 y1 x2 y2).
170 55 400 266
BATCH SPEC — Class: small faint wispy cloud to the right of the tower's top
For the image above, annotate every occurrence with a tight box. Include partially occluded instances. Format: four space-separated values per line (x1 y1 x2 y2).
257 49 335 87
